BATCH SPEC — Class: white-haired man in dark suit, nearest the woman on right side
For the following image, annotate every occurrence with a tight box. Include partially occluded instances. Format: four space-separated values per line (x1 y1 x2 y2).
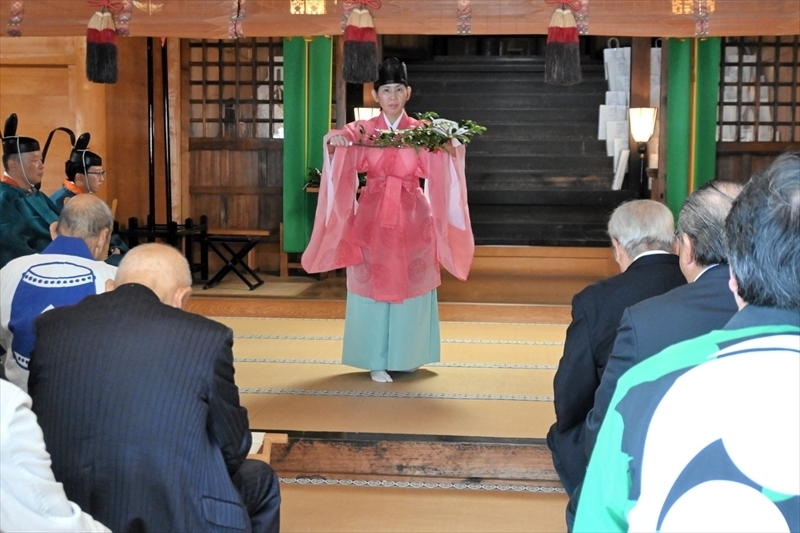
547 200 686 494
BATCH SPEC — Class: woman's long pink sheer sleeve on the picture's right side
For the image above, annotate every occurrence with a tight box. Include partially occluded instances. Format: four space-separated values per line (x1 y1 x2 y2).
421 145 475 281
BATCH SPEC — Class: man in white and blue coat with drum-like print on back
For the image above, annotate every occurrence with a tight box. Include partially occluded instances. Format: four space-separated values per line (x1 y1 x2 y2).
0 195 117 390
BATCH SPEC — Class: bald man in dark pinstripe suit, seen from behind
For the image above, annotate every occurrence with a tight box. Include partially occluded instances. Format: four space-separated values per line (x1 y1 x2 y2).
29 244 280 532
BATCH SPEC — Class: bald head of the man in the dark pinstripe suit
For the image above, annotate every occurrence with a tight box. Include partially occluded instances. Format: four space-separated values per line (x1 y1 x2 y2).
114 243 192 308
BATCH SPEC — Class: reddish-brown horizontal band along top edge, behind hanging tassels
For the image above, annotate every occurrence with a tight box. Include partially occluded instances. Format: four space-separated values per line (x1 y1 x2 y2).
0 0 800 39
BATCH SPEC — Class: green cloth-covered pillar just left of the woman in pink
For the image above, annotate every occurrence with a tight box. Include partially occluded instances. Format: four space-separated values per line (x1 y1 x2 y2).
283 36 333 253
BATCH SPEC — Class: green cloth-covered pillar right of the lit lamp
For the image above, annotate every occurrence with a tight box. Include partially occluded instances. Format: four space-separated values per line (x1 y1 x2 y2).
666 37 722 217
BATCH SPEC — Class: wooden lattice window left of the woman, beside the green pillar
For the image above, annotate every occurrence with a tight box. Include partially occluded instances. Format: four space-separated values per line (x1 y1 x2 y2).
189 37 283 139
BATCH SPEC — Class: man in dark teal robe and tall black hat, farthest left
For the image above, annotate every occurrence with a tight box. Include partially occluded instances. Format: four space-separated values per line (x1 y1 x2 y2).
0 113 59 268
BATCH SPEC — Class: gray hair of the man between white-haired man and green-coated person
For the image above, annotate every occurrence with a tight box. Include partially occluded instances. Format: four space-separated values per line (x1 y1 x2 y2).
678 180 744 267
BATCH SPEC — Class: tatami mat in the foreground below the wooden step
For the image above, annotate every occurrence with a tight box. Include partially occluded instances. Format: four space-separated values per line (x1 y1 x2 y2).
281 484 567 533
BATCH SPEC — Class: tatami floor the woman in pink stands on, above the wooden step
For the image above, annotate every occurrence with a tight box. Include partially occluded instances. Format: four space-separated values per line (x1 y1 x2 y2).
217 318 565 438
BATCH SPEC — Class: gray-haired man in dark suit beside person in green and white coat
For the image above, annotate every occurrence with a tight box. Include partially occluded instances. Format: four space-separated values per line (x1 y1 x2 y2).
586 181 742 459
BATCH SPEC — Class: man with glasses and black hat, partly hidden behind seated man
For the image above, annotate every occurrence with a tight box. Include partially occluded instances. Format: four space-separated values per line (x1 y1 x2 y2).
47 128 128 266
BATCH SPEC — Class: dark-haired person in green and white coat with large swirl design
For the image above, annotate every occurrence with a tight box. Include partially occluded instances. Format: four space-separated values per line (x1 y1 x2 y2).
575 153 800 532
